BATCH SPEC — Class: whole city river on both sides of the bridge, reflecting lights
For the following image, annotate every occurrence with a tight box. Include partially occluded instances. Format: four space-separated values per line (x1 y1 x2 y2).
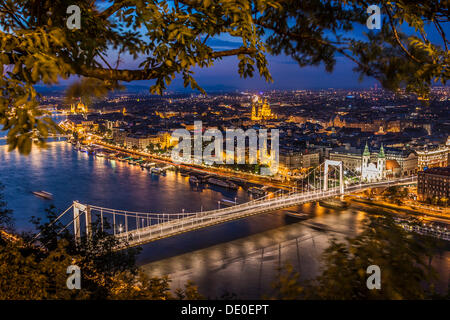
0 142 450 298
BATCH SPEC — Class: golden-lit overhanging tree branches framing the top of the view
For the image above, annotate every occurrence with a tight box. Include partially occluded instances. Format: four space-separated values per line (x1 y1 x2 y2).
0 0 450 153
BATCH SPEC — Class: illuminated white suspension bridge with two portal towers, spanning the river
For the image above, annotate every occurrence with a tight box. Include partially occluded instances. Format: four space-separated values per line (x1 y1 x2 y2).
36 160 417 249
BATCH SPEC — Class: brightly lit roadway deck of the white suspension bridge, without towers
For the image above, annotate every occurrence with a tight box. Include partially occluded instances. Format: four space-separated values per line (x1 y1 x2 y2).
111 176 417 249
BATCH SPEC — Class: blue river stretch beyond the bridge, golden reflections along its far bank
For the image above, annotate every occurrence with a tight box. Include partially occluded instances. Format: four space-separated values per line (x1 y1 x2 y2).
0 142 248 229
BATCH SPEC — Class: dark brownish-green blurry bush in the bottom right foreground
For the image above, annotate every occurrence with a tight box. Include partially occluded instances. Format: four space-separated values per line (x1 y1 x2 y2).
272 212 442 300
